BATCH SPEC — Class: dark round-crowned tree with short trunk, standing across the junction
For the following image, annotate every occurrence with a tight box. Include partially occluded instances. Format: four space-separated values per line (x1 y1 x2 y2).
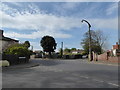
40 36 57 57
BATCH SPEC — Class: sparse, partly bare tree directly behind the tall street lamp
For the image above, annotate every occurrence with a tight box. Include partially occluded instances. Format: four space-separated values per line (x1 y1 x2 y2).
81 30 107 54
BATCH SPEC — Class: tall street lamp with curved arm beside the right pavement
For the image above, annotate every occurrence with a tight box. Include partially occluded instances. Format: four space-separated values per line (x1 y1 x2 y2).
81 19 92 61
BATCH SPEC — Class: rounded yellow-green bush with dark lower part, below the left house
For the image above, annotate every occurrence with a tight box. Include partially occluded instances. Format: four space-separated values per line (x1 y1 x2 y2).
3 44 31 64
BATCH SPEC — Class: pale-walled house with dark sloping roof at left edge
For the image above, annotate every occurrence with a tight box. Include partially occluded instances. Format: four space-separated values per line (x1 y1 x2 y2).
0 30 19 54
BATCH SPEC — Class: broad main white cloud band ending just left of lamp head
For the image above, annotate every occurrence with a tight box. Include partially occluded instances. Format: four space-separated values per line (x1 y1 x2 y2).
2 10 81 30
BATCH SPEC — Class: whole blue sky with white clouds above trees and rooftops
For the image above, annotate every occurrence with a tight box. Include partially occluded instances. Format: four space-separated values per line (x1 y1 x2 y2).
0 2 118 50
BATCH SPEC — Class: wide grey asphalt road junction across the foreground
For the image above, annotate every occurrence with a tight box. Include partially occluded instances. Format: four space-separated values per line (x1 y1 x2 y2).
2 59 118 88
